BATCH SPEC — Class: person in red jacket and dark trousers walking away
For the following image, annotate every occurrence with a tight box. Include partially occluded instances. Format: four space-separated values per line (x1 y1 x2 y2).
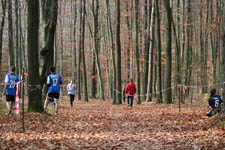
125 79 136 107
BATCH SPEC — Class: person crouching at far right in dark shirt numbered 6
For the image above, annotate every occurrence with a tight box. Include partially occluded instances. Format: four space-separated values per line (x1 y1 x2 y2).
206 88 223 117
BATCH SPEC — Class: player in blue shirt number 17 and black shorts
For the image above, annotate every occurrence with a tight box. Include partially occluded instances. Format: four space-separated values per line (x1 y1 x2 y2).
44 67 62 113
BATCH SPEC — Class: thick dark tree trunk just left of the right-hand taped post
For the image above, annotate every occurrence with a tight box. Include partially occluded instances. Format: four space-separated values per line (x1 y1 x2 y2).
163 0 172 104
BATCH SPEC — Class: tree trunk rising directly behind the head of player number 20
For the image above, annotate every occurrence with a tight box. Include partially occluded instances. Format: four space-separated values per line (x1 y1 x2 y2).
8 0 15 66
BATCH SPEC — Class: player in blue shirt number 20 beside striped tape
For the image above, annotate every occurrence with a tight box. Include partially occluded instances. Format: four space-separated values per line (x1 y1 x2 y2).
3 66 19 116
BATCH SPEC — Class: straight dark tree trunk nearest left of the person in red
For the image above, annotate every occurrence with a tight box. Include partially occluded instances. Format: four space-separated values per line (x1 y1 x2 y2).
116 0 122 104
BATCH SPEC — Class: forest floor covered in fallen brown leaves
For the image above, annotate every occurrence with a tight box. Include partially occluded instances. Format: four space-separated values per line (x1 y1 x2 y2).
0 96 225 150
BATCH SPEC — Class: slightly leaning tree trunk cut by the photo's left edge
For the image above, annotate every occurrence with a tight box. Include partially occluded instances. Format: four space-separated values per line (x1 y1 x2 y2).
0 0 7 71
